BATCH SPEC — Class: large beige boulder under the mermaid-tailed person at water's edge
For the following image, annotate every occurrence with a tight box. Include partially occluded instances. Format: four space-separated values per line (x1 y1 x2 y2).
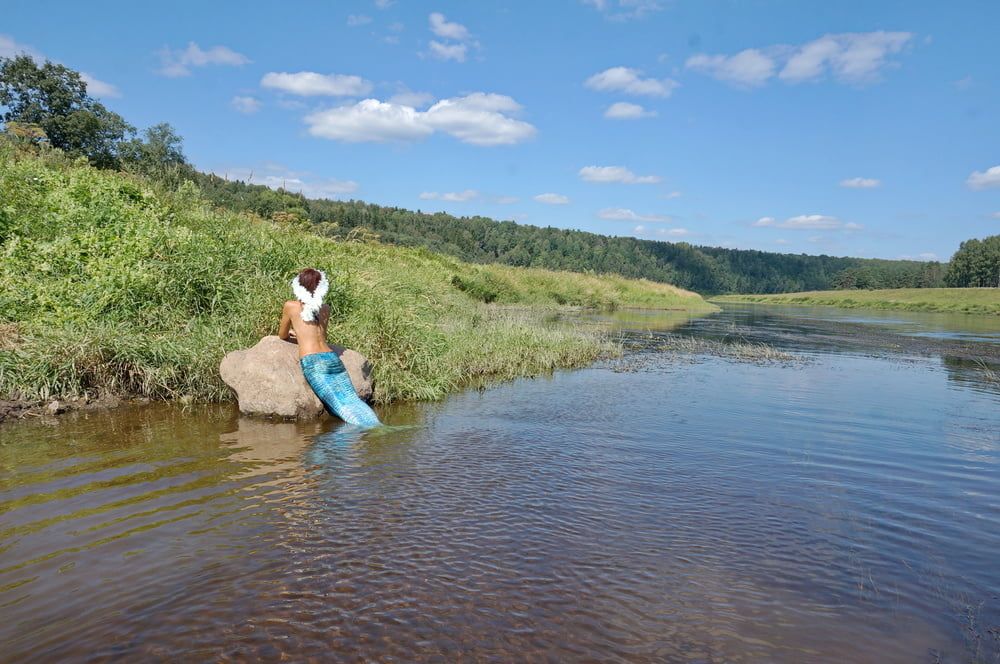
219 336 374 419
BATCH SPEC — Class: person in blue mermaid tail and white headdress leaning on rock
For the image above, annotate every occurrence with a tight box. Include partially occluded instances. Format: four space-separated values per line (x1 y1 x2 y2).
278 268 381 427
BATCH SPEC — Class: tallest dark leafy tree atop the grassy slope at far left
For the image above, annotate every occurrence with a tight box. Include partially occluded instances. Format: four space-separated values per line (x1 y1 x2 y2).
0 55 135 168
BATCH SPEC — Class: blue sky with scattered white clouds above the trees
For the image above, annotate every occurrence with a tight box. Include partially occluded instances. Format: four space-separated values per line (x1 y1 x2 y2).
0 0 1000 260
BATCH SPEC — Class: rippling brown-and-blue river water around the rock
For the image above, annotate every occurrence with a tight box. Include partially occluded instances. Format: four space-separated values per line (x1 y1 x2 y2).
0 306 1000 662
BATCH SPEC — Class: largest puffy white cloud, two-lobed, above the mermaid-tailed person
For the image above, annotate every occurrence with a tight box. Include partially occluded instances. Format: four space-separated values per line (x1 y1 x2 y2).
305 92 536 146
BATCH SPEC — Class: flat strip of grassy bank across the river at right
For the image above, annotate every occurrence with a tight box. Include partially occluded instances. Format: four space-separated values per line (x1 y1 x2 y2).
713 288 1000 316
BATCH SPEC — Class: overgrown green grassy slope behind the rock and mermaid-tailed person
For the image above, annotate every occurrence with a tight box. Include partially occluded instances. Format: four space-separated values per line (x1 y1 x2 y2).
0 145 714 402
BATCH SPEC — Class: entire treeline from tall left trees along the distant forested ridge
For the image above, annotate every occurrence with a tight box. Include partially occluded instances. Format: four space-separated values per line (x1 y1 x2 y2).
0 55 964 294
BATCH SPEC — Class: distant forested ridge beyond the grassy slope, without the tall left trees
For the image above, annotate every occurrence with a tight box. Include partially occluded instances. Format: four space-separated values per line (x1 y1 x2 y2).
195 173 945 294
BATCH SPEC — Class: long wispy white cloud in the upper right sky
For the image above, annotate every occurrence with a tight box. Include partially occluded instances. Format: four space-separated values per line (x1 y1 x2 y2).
685 30 913 87
